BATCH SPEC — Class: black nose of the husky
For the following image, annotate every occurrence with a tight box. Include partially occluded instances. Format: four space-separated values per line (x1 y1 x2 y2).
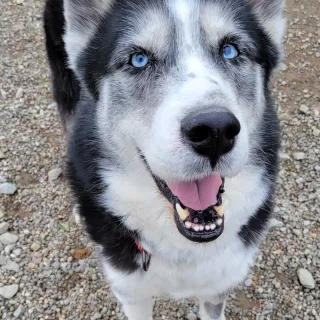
181 111 240 165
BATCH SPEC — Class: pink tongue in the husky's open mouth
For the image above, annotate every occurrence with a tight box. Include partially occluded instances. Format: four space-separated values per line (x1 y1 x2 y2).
168 175 222 210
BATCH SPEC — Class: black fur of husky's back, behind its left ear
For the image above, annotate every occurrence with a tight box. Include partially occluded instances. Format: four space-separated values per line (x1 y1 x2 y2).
44 0 80 127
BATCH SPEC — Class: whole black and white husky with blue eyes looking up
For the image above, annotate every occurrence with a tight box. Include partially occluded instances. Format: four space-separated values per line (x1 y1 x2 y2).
45 0 285 320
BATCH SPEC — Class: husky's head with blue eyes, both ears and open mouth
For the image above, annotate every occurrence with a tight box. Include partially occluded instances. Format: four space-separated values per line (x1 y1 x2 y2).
65 0 284 239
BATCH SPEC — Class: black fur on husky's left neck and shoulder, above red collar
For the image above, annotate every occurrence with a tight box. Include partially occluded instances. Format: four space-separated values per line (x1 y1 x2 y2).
68 101 139 272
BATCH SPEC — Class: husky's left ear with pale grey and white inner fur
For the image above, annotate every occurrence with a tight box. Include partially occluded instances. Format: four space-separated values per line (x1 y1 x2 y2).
64 0 113 70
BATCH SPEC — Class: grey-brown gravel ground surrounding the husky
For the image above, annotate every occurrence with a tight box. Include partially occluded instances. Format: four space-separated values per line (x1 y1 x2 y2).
0 0 320 320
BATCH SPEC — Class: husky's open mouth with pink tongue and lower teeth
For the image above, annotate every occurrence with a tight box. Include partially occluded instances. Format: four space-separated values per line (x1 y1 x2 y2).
153 171 225 242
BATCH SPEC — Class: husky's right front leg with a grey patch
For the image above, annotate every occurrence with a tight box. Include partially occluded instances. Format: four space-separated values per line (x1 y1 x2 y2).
199 296 227 320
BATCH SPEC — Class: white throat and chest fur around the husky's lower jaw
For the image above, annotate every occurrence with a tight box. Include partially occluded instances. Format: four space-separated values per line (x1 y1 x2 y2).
104 162 267 320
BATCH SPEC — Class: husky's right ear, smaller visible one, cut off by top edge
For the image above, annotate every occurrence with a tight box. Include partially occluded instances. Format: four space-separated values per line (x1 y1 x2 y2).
248 0 286 47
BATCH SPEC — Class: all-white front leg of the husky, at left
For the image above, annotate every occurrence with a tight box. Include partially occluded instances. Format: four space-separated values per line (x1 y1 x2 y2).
113 290 154 320
